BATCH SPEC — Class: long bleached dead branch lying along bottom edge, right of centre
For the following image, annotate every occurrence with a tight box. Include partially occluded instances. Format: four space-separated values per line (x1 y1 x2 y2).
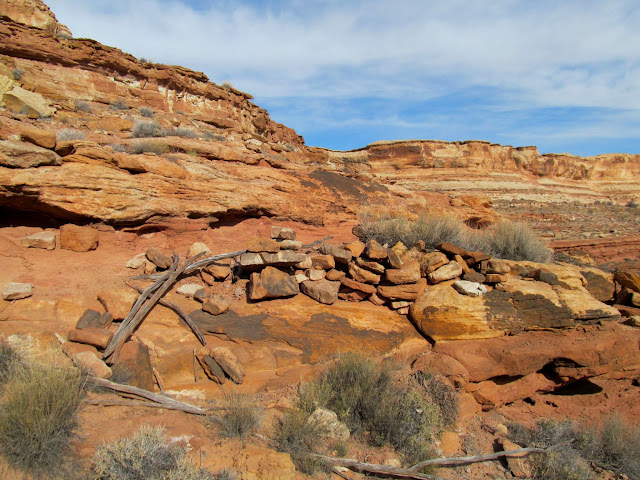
312 445 559 480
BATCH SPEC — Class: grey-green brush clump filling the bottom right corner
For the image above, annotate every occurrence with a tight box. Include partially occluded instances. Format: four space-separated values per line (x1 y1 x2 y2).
509 417 640 480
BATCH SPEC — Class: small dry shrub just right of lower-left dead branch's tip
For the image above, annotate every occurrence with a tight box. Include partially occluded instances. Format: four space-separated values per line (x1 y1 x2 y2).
212 393 262 438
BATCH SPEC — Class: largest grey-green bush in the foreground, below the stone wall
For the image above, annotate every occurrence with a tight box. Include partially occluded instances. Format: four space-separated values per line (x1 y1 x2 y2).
300 353 442 461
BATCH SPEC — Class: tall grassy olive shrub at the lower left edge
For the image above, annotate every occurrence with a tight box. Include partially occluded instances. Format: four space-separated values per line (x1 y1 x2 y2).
0 363 84 476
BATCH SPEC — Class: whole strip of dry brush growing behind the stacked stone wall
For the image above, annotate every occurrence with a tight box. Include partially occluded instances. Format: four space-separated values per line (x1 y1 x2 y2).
354 212 552 263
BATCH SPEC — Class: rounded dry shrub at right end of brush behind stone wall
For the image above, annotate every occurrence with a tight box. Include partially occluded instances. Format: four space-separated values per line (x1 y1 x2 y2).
485 222 552 263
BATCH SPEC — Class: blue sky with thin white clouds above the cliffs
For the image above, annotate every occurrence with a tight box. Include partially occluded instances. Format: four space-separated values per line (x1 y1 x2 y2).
45 0 640 155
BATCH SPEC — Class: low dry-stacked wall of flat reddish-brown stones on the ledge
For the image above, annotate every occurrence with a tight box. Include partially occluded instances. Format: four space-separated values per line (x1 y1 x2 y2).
222 227 511 314
